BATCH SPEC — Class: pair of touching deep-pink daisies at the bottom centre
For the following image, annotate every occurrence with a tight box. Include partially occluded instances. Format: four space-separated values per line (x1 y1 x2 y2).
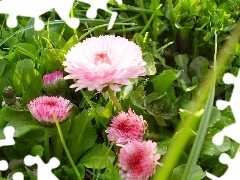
106 109 161 180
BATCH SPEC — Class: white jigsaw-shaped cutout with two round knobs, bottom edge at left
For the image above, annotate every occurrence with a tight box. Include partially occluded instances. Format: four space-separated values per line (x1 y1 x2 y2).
24 155 60 180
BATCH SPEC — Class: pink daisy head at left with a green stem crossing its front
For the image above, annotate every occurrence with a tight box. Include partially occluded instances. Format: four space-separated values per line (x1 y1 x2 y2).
27 96 72 124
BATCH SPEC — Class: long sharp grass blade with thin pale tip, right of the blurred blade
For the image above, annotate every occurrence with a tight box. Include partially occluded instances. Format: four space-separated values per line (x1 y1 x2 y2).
182 31 217 180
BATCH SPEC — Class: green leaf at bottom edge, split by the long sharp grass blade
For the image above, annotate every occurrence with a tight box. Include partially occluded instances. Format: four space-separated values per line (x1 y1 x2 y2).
170 164 206 180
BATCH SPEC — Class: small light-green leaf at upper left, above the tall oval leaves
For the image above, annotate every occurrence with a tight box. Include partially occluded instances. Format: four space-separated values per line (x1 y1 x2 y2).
16 43 38 59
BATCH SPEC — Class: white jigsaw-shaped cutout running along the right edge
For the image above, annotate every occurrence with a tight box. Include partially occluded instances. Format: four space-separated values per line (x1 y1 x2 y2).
206 70 240 180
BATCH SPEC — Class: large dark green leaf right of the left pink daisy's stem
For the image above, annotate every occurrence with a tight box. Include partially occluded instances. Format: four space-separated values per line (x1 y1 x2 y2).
68 110 97 163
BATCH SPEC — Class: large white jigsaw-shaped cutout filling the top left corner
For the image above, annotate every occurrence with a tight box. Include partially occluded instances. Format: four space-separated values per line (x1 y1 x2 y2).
0 0 80 30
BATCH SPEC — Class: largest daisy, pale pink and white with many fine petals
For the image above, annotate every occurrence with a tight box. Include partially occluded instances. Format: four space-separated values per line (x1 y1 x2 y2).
63 35 146 91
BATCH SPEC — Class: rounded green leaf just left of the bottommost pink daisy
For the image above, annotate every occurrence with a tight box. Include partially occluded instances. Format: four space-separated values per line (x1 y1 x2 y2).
80 144 115 169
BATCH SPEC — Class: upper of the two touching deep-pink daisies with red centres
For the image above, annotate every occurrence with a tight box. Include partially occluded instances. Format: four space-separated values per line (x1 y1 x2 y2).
106 109 145 146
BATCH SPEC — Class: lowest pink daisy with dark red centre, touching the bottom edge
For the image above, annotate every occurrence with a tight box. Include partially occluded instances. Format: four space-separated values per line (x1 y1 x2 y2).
118 140 161 180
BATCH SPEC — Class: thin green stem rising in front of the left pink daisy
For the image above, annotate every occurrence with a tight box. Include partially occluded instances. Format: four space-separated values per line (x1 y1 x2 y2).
52 113 82 180
